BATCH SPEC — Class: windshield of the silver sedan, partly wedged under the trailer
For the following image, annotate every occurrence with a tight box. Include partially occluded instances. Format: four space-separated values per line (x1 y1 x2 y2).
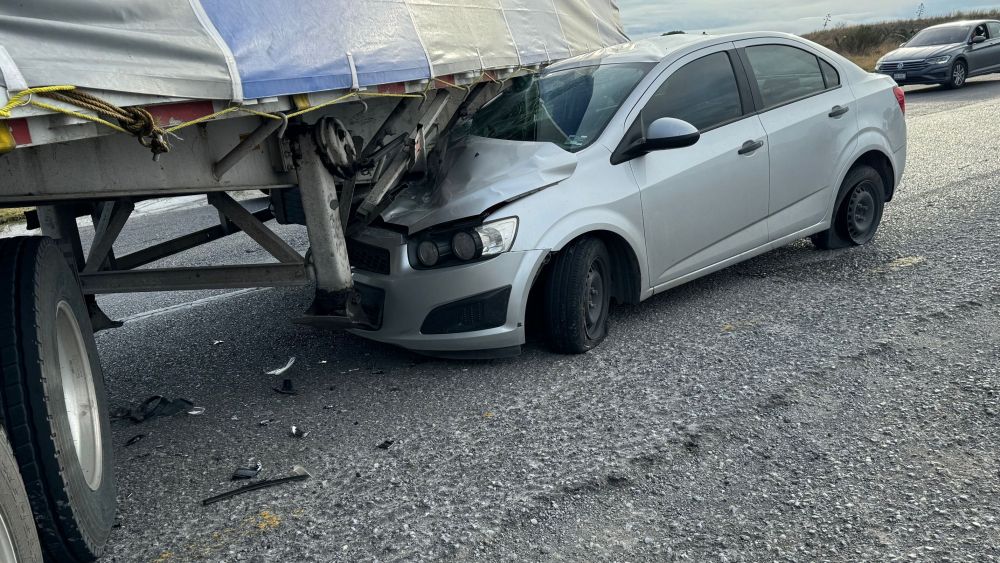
469 64 654 152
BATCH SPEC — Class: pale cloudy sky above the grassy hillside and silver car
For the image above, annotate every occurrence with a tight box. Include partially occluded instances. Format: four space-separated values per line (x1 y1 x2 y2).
618 0 1000 39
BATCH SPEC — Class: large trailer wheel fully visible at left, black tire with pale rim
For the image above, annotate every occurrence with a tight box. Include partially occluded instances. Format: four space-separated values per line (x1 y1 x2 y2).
0 237 115 562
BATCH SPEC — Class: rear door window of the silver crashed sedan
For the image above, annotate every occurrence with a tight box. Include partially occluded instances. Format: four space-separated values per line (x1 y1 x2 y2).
746 45 828 109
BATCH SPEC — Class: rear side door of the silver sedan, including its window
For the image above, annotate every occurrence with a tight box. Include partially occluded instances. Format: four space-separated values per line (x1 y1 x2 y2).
736 39 858 240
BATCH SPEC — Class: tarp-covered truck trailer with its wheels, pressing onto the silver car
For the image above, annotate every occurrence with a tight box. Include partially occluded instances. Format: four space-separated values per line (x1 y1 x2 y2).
0 0 627 562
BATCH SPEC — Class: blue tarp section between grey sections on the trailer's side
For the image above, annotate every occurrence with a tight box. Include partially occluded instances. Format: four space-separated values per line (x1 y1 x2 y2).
201 0 430 98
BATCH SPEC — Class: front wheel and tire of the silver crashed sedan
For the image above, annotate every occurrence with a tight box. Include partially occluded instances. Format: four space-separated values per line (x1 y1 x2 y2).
545 238 613 354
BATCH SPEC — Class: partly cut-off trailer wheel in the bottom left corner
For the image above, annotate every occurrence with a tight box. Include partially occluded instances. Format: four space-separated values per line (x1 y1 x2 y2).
0 429 42 563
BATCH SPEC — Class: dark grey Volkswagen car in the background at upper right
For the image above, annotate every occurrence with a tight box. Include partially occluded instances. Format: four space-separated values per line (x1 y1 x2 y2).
875 21 1000 88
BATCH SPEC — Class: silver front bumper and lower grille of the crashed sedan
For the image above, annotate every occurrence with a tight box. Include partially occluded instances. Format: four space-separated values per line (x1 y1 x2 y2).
348 228 547 357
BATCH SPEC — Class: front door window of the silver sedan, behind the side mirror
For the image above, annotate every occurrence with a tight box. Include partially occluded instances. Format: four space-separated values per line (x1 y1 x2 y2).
639 53 743 132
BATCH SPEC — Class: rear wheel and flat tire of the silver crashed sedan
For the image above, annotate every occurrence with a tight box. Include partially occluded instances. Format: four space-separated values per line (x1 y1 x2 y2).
811 165 885 250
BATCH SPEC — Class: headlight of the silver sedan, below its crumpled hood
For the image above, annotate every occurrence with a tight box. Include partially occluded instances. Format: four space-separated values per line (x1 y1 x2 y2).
409 217 518 269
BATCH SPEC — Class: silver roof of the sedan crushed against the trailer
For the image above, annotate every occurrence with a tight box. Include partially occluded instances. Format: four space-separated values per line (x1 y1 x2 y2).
547 32 799 70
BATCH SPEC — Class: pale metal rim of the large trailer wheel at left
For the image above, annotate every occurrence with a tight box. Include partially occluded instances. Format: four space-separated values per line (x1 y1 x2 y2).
56 301 104 491
